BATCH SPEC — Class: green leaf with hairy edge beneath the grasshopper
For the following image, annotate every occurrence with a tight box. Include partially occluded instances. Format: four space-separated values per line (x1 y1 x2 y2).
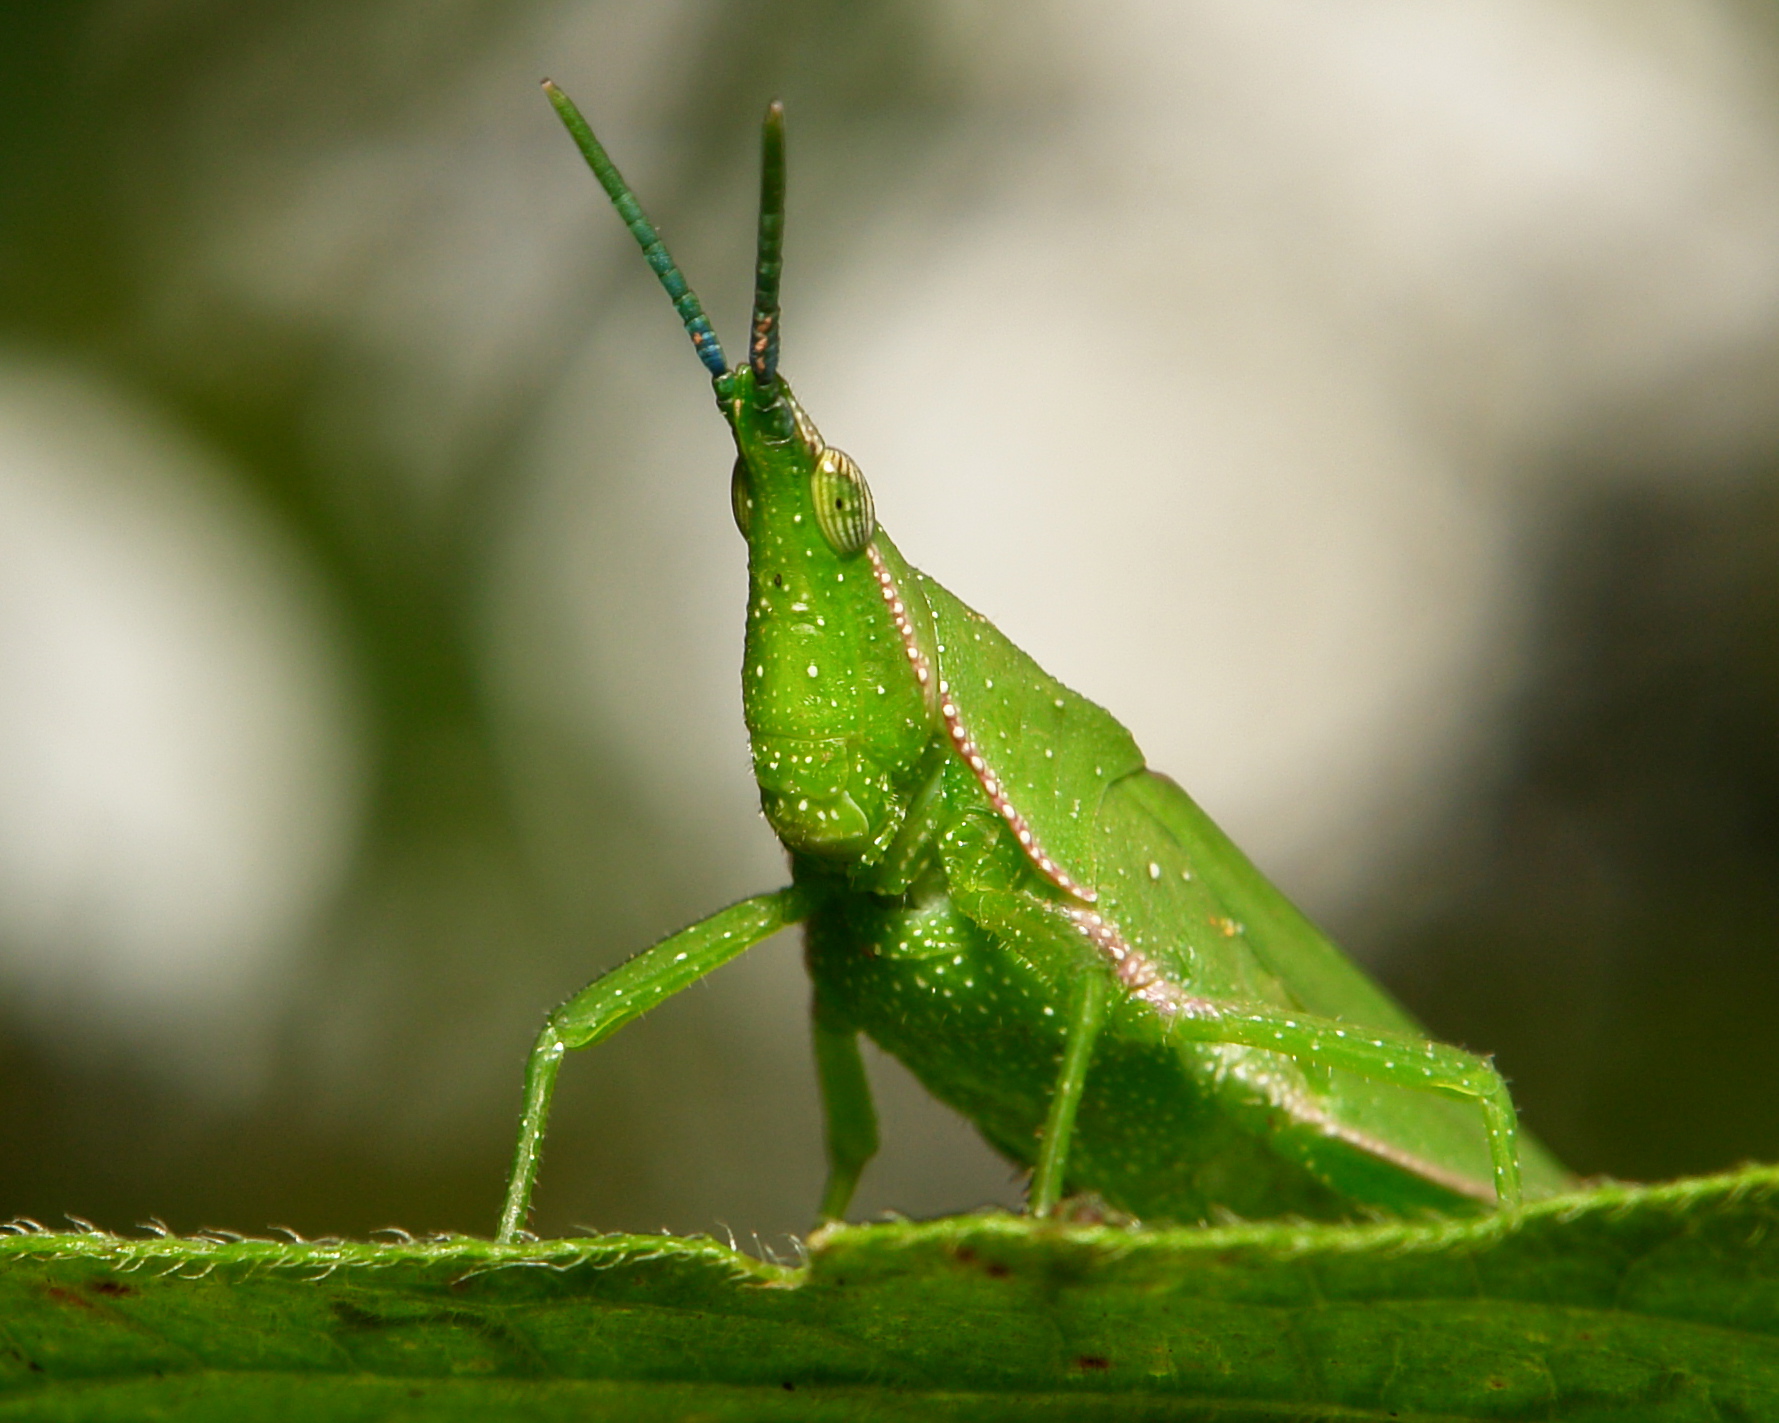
0 1167 1779 1423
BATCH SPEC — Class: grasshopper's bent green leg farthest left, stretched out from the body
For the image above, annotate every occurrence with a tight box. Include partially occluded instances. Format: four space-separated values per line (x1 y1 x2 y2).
498 884 811 1242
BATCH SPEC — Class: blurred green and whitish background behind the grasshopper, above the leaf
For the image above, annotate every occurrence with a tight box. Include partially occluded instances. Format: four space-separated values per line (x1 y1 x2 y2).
0 0 1779 1240
